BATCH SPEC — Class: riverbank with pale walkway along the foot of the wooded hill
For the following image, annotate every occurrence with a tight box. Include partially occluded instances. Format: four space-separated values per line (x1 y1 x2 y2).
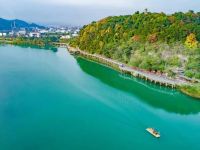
67 45 200 99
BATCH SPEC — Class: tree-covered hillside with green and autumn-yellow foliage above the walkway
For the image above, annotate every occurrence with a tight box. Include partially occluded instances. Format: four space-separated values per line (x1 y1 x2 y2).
70 10 200 79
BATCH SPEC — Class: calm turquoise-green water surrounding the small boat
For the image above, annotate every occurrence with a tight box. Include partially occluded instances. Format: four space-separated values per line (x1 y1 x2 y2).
0 45 200 150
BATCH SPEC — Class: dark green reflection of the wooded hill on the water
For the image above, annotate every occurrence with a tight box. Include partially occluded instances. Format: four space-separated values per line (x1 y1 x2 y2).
76 58 200 115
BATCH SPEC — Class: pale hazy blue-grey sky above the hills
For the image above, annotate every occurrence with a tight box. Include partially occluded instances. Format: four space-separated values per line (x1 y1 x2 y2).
0 0 200 25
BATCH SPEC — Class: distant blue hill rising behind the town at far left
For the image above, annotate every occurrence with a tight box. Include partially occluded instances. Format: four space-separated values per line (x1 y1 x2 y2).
0 18 45 31
